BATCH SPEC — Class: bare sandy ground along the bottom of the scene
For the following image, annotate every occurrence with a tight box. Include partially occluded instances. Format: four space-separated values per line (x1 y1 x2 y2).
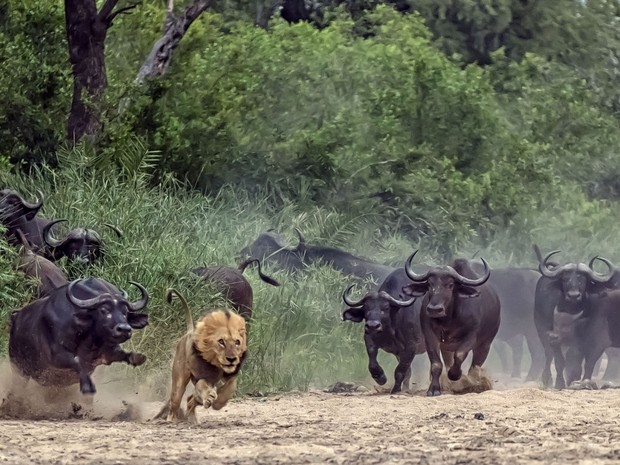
0 387 620 465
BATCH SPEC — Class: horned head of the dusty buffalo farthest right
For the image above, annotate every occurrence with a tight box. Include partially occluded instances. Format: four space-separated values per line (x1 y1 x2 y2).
538 250 614 303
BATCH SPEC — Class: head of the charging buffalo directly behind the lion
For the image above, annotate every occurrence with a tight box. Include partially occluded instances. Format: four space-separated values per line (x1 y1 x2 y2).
67 278 149 344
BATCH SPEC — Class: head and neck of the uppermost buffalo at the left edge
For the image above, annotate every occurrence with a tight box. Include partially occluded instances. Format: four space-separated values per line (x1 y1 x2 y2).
0 189 49 252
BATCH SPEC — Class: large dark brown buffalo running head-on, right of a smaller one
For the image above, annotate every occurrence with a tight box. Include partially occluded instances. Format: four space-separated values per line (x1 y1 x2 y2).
403 251 500 396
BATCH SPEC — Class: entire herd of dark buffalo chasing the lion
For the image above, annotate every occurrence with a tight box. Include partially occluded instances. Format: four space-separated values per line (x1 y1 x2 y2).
0 189 620 416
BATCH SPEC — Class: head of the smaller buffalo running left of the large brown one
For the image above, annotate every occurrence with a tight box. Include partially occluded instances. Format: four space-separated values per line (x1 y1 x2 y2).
342 284 416 335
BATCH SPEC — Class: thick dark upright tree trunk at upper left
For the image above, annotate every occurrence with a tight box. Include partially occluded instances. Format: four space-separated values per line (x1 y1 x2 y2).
65 0 139 142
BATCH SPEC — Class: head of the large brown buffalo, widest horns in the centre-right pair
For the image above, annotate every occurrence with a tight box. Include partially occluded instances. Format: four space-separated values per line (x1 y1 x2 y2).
403 250 491 318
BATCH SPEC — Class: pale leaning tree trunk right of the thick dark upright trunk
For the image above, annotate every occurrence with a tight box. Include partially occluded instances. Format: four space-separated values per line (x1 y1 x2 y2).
136 0 210 84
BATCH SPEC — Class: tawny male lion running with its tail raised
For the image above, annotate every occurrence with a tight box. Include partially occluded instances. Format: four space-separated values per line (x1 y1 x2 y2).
155 289 247 424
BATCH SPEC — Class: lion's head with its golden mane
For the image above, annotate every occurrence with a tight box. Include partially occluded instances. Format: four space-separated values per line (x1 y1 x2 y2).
193 310 247 373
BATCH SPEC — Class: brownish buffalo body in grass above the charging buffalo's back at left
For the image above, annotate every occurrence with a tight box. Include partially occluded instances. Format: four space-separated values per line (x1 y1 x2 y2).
17 229 69 298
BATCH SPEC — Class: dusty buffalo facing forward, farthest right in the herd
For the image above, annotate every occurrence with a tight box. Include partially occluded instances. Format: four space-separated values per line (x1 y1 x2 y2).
534 250 614 389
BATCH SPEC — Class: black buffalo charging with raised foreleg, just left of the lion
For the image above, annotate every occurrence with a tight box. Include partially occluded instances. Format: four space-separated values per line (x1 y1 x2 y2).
9 278 148 394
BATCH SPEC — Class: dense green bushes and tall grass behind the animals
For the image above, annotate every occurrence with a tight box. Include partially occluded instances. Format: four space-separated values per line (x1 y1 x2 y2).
0 0 620 389
